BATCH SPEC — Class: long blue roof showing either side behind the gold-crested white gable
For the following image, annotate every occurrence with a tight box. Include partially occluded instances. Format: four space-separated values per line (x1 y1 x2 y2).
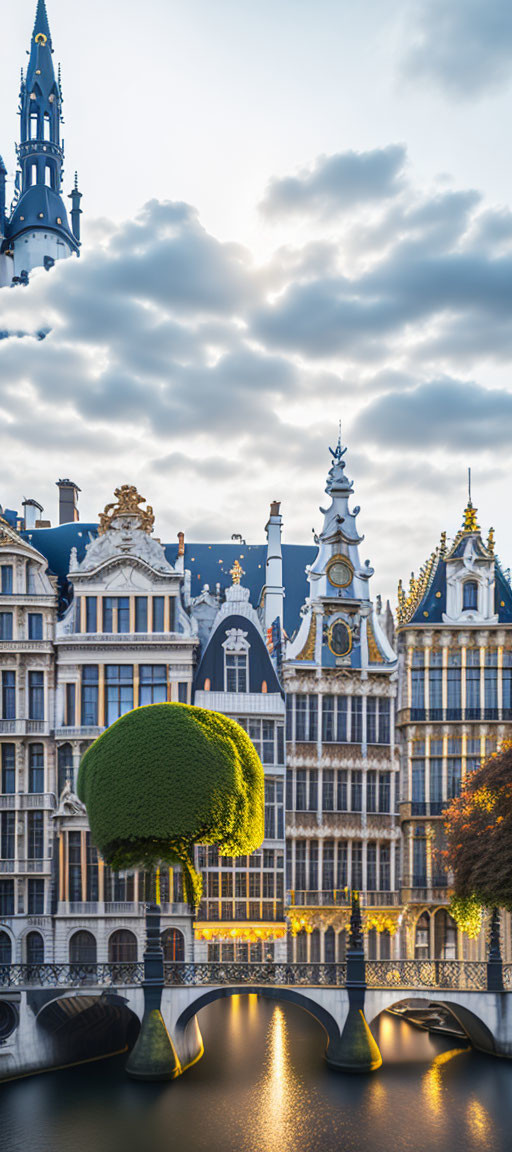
21 521 317 636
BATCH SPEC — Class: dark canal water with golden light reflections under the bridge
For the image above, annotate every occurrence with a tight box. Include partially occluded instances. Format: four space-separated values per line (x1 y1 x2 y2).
0 995 512 1152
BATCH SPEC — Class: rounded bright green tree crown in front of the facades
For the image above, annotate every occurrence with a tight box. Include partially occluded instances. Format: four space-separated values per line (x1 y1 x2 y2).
77 704 264 905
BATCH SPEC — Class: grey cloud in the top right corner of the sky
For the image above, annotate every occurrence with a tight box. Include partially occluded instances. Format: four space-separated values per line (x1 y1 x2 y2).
405 0 512 99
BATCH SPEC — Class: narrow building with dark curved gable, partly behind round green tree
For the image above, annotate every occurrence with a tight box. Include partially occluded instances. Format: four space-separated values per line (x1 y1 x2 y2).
190 543 286 961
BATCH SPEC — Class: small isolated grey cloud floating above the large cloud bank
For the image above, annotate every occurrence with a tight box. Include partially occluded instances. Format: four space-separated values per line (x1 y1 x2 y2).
261 144 406 218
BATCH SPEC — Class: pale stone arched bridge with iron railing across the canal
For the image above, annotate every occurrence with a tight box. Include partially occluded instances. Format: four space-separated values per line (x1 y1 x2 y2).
0 958 512 1079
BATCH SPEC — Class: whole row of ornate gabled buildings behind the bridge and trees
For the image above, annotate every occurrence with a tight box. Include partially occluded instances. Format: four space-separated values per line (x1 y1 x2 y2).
0 442 512 963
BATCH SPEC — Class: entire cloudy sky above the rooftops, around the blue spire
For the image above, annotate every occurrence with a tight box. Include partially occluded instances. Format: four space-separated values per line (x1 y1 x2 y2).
0 0 512 597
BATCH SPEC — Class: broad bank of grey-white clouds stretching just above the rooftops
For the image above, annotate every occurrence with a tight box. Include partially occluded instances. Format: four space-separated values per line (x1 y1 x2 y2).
0 145 512 592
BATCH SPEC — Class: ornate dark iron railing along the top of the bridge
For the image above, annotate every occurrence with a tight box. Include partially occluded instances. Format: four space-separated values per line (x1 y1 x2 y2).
0 960 498 992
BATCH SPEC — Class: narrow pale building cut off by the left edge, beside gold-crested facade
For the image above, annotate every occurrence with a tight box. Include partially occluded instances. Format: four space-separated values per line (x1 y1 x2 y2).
0 518 58 963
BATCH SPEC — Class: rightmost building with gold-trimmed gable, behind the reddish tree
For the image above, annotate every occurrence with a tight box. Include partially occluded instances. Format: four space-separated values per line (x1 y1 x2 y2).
397 499 512 958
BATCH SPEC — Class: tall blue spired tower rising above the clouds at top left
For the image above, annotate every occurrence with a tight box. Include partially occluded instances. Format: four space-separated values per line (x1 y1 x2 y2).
0 0 81 287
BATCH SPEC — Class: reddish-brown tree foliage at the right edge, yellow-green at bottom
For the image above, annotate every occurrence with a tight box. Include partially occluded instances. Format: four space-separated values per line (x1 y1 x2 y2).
444 744 512 925
